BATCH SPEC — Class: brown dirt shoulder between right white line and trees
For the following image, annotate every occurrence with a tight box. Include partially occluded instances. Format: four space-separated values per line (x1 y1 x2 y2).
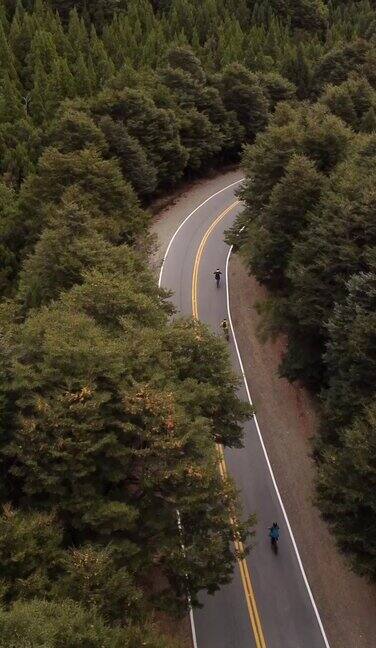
229 255 376 648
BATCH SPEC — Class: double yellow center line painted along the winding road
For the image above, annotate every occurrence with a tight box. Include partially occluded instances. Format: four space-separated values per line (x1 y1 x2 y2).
192 200 266 648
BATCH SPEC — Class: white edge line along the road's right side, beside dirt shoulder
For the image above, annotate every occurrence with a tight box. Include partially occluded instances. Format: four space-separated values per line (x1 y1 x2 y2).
225 245 330 648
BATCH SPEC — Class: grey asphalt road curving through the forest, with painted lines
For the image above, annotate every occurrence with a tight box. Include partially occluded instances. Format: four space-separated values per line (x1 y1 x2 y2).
160 181 329 648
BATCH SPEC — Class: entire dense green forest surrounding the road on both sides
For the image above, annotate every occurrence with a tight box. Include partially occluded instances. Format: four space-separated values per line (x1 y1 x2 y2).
0 0 376 648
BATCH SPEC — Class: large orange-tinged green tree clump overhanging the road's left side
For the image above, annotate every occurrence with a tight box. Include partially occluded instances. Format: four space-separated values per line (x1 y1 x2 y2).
3 292 253 603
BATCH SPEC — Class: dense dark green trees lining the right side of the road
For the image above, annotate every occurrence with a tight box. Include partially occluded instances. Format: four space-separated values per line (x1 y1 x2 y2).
228 2 376 579
